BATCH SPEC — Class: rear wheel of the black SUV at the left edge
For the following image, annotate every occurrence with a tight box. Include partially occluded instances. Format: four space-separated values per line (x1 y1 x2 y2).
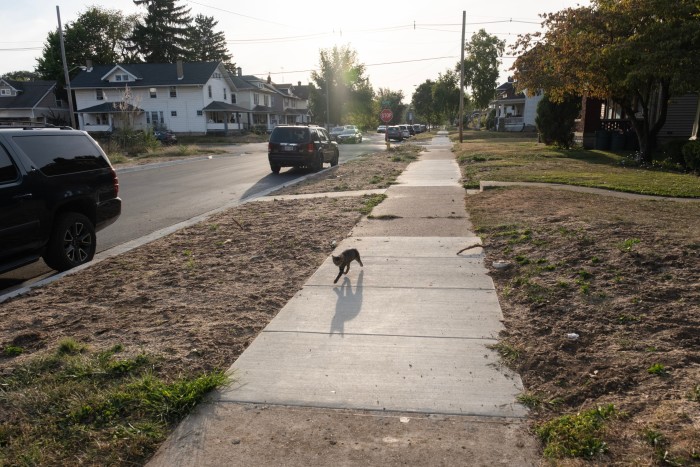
44 212 97 271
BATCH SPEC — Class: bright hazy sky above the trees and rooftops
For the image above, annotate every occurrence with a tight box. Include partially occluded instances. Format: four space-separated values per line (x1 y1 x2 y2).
0 0 589 102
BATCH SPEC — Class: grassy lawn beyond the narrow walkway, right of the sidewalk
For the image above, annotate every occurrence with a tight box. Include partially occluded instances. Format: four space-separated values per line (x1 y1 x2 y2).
454 132 700 198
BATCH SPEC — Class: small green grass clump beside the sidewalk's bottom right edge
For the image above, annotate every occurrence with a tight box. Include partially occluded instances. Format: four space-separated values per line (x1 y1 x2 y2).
535 404 618 459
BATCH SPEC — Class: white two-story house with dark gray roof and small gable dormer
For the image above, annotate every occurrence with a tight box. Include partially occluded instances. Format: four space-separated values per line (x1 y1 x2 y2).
71 61 251 134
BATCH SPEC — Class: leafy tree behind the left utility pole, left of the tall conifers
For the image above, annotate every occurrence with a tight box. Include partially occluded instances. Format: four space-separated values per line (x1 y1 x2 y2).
36 7 137 85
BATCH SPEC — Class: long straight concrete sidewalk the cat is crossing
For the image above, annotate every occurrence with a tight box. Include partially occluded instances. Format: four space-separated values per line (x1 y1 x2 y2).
149 133 539 466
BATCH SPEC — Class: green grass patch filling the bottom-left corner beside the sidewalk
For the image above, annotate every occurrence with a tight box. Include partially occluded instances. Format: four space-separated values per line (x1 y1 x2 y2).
0 339 227 465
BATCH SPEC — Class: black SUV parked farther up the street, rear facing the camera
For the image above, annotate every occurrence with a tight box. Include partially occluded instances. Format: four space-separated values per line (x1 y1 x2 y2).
267 125 340 173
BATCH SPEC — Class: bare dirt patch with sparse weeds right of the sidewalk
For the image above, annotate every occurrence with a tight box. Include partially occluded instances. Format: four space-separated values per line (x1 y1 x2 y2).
467 188 700 465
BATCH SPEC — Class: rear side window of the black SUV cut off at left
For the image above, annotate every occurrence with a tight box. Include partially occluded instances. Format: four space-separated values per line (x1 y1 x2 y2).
13 135 109 177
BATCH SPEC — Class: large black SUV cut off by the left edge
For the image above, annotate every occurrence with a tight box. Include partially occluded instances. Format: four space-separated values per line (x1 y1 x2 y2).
0 128 121 273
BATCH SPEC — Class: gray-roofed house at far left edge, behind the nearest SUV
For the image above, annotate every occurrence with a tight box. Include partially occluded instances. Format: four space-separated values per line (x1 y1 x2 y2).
0 78 70 125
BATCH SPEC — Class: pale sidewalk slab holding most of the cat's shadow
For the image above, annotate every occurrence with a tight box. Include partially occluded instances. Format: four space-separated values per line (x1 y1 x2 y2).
265 286 503 339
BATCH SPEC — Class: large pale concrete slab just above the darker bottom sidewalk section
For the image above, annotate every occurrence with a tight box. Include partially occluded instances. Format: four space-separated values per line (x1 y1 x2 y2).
218 331 527 417
